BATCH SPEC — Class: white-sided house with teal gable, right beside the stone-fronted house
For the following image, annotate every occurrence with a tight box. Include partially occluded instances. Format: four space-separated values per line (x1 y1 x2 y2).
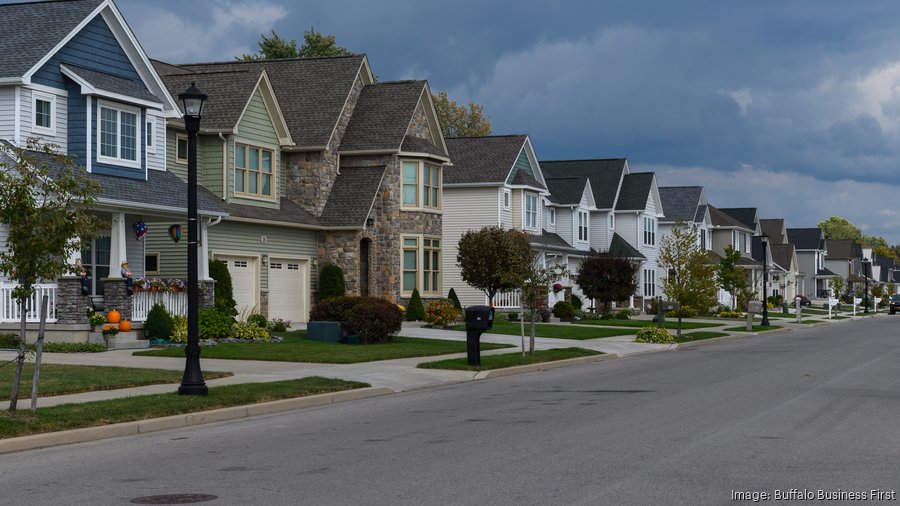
443 135 552 309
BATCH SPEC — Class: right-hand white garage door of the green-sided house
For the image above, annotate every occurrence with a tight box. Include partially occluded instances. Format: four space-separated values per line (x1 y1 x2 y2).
269 258 309 322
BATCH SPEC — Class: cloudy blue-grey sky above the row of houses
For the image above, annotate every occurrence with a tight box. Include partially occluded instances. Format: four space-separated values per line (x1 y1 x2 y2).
117 0 900 244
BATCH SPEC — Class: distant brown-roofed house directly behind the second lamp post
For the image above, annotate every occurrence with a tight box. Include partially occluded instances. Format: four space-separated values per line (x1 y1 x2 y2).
753 218 804 303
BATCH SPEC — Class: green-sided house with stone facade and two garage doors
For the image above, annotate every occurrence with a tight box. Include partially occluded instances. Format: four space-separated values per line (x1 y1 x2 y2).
149 55 449 321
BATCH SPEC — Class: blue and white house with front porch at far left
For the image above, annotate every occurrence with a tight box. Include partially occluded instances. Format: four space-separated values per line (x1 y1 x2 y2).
0 0 227 339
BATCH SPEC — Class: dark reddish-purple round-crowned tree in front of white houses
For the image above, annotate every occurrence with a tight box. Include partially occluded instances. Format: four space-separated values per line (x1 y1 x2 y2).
575 252 638 315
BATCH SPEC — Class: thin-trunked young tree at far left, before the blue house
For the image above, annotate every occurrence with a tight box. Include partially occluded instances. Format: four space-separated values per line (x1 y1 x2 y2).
0 139 100 411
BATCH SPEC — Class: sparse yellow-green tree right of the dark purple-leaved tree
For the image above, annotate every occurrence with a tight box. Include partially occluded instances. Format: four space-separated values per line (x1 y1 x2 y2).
659 223 717 314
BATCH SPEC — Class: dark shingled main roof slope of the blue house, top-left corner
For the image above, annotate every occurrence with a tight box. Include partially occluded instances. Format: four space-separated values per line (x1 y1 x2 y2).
0 0 103 79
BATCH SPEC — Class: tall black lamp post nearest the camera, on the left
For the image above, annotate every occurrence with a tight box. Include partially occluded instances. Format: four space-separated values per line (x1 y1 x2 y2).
178 83 209 395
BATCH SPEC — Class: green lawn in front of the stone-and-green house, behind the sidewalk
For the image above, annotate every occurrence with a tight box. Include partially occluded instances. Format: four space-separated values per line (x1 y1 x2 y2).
135 330 510 364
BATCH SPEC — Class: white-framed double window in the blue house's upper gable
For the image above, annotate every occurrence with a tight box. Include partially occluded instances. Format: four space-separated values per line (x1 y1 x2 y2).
97 102 141 167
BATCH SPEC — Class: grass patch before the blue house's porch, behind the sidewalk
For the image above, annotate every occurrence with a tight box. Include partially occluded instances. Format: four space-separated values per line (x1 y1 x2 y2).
0 363 231 400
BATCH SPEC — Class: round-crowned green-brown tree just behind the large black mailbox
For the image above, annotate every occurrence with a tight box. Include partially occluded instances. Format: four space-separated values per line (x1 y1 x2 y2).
456 226 532 305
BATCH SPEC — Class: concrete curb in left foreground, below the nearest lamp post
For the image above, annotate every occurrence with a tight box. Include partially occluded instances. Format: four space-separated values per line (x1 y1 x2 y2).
0 387 394 455
